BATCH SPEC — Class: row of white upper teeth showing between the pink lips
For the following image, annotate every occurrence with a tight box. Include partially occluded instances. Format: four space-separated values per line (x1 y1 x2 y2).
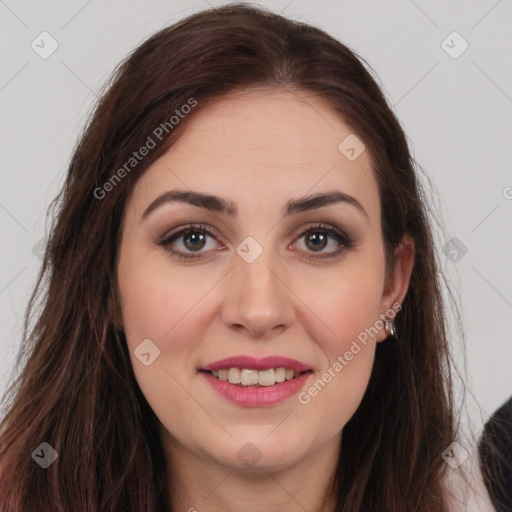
200 368 311 388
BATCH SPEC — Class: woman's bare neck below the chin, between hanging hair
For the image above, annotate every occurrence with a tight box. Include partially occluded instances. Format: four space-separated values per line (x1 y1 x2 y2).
163 429 341 512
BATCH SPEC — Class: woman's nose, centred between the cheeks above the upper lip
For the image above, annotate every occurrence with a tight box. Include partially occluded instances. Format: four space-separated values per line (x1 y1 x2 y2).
222 251 295 339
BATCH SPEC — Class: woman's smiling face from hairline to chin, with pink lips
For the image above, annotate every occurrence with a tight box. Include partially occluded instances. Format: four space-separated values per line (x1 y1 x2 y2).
117 90 410 471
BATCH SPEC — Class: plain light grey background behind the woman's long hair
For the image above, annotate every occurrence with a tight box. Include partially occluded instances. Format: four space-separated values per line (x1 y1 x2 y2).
0 0 512 440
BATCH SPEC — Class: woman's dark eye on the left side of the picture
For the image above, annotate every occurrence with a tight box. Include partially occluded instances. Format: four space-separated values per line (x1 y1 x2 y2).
158 224 223 259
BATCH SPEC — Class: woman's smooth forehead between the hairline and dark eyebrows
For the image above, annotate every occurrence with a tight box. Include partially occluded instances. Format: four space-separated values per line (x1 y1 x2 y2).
127 89 380 224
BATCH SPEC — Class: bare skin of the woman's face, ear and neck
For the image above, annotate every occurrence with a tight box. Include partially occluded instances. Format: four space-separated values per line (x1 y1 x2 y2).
117 89 414 512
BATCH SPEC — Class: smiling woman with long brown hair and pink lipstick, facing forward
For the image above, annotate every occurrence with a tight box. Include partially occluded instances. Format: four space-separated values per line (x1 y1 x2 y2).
0 5 496 512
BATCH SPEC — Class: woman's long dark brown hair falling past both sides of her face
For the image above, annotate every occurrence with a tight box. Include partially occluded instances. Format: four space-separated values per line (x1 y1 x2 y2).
0 4 462 512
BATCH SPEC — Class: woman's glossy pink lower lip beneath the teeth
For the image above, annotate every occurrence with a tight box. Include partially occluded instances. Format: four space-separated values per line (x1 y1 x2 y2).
200 371 312 407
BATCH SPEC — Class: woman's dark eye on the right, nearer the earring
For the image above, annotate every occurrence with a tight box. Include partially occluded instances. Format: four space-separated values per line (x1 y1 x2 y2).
292 224 353 259
